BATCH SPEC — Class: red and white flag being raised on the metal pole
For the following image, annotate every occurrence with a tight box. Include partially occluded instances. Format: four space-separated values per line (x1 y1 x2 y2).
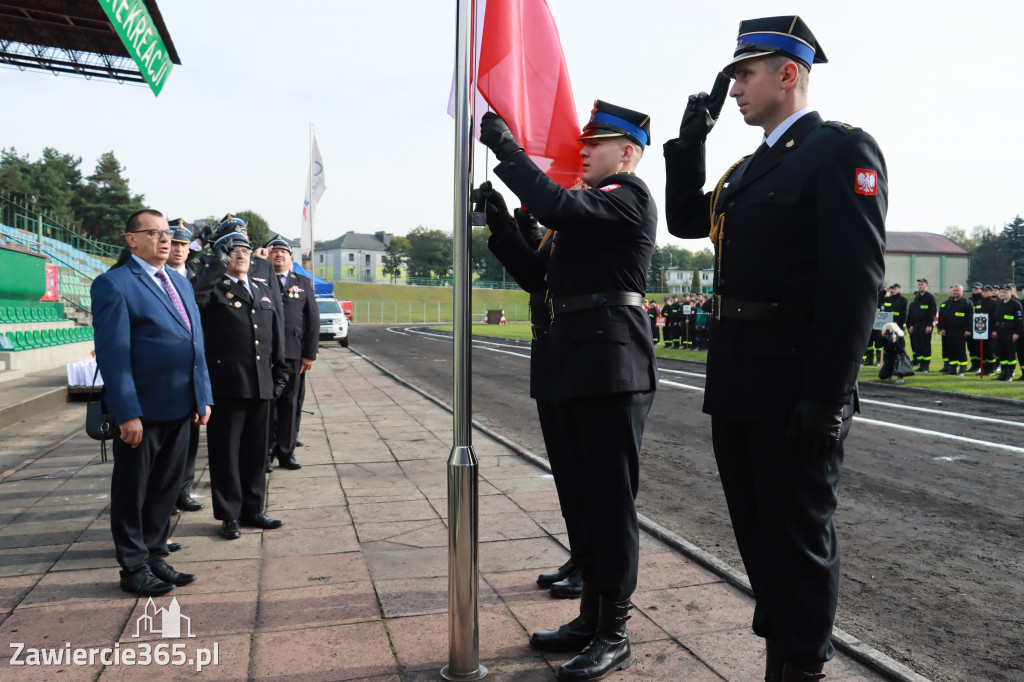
449 0 582 187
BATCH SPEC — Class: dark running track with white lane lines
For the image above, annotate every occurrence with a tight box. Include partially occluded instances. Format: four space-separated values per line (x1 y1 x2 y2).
351 325 1024 681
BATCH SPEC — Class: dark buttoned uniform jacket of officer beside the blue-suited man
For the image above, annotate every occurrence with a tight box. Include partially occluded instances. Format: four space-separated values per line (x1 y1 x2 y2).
193 261 288 400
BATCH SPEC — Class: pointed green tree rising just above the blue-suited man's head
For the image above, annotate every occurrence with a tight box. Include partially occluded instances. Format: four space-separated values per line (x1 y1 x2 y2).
78 152 144 244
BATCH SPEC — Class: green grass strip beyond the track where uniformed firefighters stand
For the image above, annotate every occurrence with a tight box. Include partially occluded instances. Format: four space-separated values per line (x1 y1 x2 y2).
434 324 1024 400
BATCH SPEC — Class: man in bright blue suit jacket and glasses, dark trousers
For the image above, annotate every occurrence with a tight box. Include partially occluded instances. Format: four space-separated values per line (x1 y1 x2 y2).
91 209 213 596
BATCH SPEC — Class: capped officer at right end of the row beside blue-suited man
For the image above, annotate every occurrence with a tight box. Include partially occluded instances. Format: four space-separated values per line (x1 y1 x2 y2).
264 237 319 469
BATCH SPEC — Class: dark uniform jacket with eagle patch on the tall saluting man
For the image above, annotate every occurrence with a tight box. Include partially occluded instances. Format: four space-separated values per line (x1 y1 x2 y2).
665 112 888 421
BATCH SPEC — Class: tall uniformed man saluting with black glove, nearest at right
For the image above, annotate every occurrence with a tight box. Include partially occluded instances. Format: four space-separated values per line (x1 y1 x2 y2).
665 16 888 682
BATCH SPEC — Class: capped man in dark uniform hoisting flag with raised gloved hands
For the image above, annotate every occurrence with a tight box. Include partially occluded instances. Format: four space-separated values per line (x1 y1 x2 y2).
480 100 657 680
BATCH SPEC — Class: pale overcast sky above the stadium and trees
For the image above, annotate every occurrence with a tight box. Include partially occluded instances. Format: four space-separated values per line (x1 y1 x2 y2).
0 0 1024 250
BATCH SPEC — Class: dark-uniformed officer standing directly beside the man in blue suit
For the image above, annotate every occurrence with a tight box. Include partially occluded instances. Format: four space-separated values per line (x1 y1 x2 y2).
193 232 288 540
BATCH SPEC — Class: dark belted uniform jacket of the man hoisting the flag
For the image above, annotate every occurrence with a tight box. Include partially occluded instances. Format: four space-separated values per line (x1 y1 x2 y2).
495 154 657 401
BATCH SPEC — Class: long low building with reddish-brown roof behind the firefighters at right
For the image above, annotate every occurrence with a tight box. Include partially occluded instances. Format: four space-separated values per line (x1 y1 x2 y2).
885 232 971 294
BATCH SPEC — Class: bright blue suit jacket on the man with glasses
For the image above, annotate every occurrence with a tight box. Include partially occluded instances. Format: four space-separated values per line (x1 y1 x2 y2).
91 258 213 424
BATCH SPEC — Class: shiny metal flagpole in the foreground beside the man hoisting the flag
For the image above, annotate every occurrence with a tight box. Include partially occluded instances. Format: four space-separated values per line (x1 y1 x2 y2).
441 0 487 680
